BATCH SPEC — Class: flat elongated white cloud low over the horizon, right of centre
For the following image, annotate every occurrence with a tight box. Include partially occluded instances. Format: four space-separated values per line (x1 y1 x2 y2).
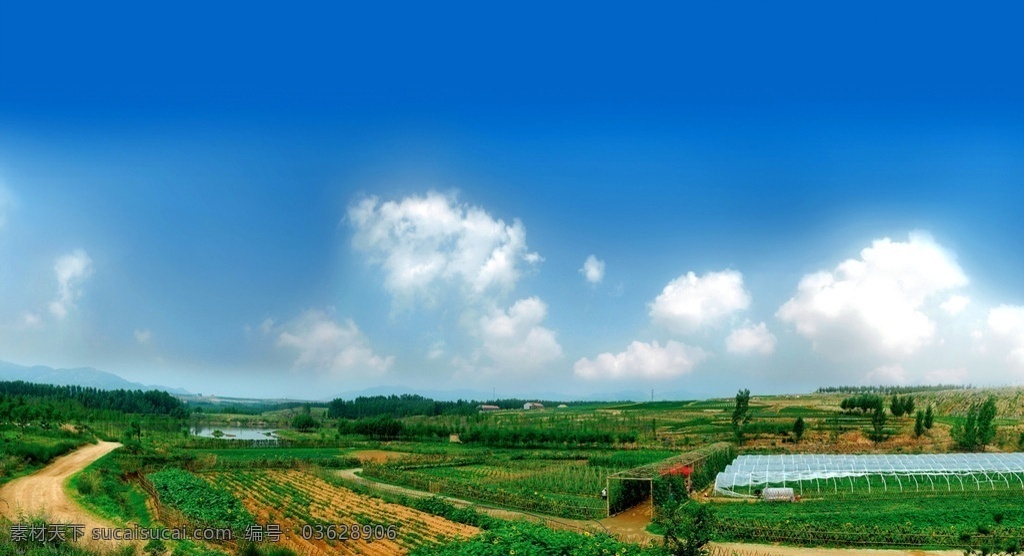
572 340 708 379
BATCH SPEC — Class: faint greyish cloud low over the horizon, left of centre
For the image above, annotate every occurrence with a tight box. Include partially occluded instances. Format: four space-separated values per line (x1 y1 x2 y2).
278 310 394 376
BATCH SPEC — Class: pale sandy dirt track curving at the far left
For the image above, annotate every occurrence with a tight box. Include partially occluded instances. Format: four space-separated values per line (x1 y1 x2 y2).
0 442 121 539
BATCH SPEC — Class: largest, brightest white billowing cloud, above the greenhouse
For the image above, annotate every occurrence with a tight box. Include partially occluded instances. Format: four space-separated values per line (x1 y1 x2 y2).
776 232 968 356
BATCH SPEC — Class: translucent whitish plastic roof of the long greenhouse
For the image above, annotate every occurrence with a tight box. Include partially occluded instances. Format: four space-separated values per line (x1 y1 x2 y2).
715 453 1024 495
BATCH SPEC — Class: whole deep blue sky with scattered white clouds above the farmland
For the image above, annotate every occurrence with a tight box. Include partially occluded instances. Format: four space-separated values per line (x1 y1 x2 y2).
0 3 1024 397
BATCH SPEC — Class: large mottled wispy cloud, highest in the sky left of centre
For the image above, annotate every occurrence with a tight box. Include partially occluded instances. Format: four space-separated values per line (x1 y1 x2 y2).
348 191 542 301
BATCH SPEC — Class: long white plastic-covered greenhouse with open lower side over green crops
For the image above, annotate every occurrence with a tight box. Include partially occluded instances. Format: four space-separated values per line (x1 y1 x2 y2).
715 453 1024 498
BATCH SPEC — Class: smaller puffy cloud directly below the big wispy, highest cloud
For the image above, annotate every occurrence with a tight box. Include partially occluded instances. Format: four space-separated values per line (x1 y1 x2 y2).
479 297 562 372
